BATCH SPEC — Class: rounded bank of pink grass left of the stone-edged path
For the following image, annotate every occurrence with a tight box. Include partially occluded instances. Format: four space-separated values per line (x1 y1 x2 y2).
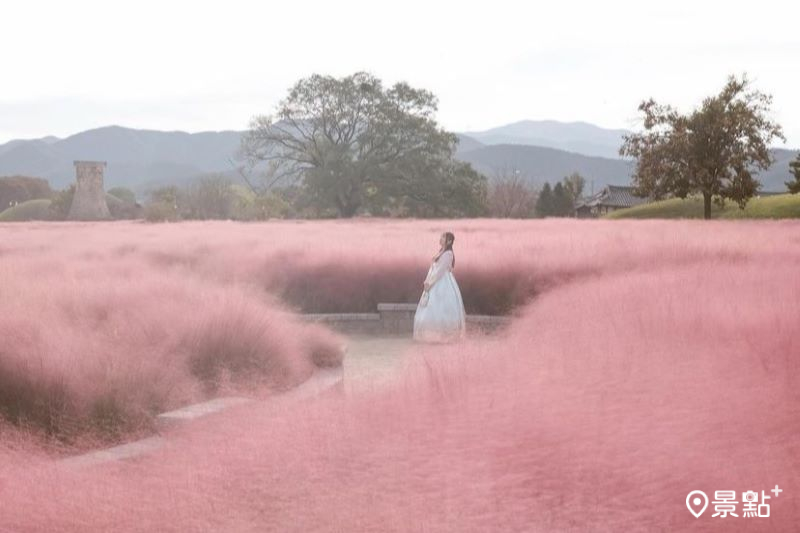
0 230 341 442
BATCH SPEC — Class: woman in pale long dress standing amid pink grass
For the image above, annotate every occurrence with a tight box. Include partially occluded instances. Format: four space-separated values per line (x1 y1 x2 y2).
414 232 466 342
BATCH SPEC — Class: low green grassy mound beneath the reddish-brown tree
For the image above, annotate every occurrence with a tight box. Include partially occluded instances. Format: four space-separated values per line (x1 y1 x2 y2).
604 194 800 219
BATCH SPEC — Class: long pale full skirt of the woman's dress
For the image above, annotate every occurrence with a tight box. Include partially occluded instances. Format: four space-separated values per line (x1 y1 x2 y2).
414 272 466 342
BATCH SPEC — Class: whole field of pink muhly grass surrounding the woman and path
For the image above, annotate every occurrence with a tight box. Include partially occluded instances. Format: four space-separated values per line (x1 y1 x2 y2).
0 220 800 532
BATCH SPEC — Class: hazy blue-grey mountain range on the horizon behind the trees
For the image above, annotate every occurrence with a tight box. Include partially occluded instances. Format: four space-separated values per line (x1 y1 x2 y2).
0 121 797 193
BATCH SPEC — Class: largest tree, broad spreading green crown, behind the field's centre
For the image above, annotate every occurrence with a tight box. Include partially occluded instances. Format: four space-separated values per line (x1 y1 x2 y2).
242 72 487 217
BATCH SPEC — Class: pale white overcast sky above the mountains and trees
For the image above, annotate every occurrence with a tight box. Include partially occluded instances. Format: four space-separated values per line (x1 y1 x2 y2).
0 0 800 147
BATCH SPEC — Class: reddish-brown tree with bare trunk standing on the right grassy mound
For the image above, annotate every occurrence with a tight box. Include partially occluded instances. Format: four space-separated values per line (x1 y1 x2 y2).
620 76 784 219
